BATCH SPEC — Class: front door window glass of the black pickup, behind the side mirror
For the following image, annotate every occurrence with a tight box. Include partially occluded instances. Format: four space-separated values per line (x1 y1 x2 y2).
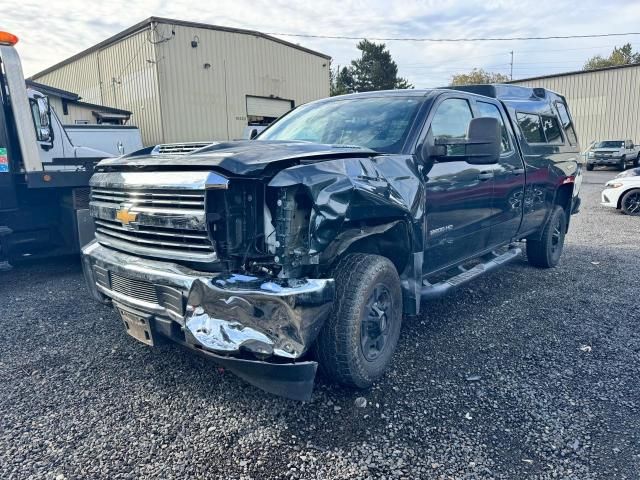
431 98 473 156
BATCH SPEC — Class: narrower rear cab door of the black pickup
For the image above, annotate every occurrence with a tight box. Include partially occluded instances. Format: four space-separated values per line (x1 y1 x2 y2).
475 99 525 246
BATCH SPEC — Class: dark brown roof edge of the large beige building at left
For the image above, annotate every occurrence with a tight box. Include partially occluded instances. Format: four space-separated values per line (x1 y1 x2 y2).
29 17 331 80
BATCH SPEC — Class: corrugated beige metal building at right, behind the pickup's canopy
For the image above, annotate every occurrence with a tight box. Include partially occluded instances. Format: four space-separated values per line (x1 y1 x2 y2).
510 65 640 149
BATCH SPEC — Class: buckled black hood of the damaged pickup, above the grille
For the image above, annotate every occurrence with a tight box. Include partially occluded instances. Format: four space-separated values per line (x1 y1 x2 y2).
98 140 376 175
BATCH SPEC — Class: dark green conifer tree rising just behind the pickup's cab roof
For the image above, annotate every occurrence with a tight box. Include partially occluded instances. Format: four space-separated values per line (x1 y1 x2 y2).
331 40 413 95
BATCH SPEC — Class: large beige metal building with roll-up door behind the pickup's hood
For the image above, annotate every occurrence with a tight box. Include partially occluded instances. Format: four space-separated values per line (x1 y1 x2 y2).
30 17 330 145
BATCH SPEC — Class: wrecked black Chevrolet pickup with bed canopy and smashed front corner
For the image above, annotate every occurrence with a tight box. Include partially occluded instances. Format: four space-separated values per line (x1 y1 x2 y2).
83 85 582 400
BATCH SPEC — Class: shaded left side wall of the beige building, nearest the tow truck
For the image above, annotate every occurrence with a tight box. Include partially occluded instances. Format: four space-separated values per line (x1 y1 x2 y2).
33 29 163 145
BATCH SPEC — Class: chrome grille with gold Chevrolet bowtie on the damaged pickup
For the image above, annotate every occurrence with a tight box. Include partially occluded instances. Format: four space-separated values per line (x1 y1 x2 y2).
89 170 229 263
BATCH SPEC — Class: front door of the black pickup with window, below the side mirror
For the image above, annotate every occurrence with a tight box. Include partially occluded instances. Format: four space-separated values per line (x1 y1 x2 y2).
424 97 495 272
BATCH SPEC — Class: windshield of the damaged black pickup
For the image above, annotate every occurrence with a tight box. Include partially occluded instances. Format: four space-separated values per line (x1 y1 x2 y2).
257 96 424 153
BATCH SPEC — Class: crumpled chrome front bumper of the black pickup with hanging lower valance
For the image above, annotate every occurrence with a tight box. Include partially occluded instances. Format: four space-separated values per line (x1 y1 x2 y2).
82 242 335 400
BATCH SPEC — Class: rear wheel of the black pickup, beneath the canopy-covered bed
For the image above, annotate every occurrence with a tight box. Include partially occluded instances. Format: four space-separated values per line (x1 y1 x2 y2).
527 206 567 268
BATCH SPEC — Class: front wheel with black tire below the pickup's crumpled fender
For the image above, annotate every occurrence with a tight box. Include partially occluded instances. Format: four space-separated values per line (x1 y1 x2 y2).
314 253 402 388
